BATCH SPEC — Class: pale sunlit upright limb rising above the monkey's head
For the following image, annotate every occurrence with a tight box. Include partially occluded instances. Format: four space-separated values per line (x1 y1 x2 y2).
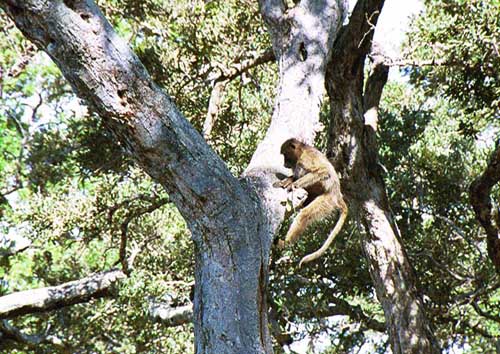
247 0 346 173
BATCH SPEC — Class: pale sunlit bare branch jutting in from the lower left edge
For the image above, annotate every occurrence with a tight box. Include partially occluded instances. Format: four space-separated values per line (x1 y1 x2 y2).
0 270 126 319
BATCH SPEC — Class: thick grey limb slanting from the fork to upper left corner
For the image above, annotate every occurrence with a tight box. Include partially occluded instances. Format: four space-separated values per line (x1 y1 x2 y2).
0 0 248 227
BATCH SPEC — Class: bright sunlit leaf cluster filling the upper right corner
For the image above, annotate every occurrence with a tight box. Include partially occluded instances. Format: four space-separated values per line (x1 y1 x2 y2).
407 0 500 123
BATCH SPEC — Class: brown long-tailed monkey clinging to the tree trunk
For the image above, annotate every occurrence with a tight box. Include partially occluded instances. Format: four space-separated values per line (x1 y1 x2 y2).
278 139 347 267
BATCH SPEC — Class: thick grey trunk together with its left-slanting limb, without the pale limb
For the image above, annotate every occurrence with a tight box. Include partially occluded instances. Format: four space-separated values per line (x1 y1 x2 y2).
0 0 272 353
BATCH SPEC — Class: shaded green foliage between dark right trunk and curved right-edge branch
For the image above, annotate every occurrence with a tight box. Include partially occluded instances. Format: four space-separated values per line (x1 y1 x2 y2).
380 85 500 350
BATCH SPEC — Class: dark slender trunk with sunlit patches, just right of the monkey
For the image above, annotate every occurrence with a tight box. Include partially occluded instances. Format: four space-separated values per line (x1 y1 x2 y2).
327 0 440 354
